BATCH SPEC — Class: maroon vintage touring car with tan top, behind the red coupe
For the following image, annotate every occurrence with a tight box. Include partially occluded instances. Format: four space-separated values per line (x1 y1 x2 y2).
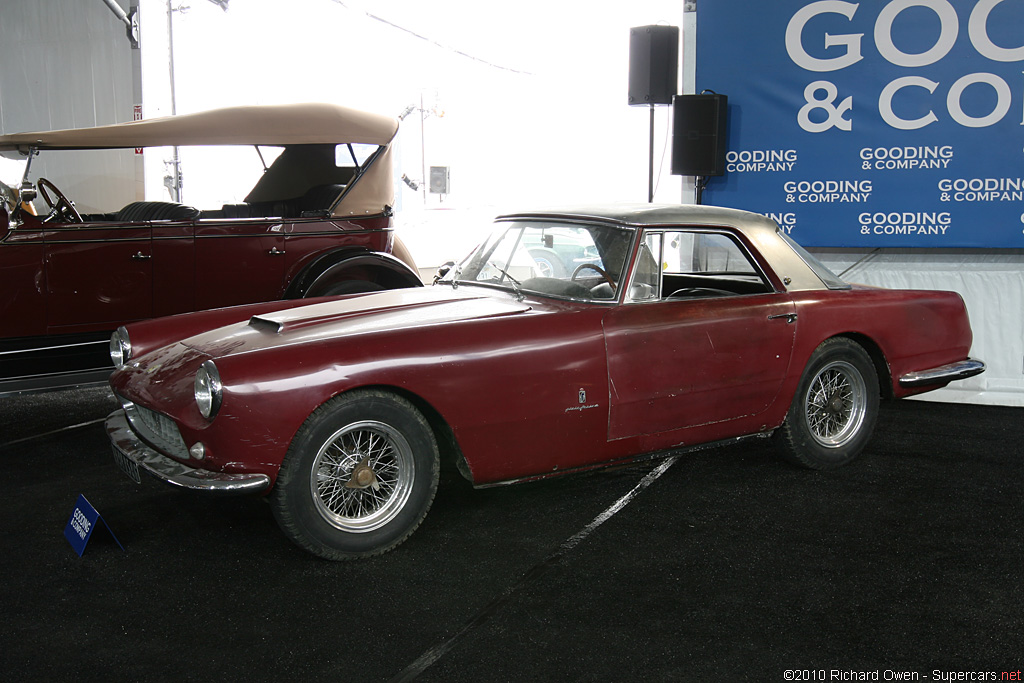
0 104 422 395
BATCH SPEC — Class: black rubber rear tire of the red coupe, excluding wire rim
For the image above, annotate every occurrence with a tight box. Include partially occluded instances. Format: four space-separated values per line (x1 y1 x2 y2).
774 337 880 470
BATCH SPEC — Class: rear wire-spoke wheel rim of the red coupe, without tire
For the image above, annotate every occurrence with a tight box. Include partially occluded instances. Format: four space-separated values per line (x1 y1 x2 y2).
804 360 867 449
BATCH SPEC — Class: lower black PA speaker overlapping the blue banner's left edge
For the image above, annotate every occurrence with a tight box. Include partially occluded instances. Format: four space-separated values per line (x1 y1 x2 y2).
672 94 729 176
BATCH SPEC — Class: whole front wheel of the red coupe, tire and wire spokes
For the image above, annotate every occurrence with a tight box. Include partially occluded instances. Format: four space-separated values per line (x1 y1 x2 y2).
270 390 439 560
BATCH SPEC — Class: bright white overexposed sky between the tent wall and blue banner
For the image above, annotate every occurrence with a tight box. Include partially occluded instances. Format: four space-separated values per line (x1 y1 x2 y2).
142 0 683 264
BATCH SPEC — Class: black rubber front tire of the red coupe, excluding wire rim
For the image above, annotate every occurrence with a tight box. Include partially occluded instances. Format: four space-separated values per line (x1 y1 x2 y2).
269 389 440 560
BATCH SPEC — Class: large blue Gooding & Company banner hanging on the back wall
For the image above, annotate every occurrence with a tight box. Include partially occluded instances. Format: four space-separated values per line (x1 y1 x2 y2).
696 0 1024 248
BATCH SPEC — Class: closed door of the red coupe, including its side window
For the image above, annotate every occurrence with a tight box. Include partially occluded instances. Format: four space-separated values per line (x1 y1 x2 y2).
604 231 796 439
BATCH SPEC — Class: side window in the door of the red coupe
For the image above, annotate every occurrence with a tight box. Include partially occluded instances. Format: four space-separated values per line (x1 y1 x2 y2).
628 229 773 301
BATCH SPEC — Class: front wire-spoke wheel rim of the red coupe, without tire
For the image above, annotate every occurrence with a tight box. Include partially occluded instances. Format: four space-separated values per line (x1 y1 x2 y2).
309 421 416 533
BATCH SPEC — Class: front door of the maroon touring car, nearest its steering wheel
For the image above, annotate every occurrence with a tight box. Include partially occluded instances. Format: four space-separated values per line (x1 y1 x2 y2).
43 222 153 334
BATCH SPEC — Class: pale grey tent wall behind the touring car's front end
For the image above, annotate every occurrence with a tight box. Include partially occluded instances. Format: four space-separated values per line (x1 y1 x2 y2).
0 0 141 213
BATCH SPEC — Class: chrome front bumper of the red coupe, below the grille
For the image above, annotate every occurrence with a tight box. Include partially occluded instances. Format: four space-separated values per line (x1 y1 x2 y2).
105 411 270 494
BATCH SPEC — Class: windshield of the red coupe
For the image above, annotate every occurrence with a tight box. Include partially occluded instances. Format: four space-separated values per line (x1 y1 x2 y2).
441 220 635 301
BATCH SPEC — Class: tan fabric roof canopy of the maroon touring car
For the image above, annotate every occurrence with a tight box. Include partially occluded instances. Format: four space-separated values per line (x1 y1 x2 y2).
0 103 398 152
